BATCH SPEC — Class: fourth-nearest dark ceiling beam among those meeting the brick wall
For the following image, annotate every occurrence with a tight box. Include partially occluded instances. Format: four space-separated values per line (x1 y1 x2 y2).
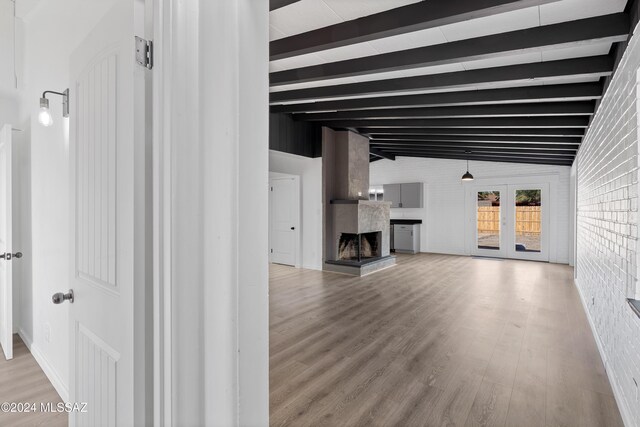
293 101 596 121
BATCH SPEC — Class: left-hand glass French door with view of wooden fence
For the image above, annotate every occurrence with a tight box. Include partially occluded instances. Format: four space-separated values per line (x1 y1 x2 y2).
471 185 507 258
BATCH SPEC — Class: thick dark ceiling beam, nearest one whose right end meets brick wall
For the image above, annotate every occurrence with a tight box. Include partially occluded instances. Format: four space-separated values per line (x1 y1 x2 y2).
269 13 630 86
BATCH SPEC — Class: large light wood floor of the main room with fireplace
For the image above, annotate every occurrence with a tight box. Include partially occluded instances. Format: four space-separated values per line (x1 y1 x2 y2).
270 254 623 427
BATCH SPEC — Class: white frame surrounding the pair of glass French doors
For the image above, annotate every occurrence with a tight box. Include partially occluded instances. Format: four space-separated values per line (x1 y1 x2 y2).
464 174 560 263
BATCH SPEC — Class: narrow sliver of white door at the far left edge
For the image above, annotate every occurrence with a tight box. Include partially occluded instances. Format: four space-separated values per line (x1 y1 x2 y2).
0 125 13 360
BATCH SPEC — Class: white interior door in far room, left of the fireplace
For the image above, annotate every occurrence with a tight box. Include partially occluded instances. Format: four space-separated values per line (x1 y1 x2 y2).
270 177 300 266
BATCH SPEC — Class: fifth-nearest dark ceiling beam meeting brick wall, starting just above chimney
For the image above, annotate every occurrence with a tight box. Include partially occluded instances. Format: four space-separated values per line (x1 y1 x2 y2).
326 116 589 129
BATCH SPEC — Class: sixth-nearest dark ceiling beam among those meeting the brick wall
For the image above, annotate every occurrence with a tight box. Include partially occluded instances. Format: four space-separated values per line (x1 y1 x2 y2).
357 126 584 138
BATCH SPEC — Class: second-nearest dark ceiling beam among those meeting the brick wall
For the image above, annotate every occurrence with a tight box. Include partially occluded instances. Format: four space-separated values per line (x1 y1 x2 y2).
270 55 614 103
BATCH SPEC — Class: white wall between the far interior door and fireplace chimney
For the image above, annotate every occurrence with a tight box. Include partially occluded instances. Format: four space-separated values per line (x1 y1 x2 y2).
269 150 322 270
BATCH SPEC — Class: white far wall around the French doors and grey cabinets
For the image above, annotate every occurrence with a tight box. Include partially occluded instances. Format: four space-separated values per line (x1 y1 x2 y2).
370 157 570 263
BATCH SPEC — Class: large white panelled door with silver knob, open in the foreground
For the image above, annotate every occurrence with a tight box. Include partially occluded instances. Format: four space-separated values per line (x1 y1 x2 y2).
64 0 145 426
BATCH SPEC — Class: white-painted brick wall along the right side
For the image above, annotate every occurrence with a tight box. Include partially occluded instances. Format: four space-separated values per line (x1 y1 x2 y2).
576 25 640 426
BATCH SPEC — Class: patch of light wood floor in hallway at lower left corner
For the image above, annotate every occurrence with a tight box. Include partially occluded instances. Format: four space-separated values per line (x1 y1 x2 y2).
0 335 68 427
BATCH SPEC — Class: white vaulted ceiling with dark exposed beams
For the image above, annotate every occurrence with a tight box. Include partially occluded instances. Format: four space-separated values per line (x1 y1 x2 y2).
270 0 631 166
